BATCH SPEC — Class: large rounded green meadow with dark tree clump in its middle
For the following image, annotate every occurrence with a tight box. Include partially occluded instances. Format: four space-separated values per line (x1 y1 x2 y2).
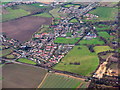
53 46 99 76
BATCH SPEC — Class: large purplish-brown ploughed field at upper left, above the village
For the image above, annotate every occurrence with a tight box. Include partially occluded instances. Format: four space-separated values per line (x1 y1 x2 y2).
2 16 52 42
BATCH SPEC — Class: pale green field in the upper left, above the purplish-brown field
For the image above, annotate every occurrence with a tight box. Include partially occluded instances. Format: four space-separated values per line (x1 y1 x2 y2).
2 7 30 21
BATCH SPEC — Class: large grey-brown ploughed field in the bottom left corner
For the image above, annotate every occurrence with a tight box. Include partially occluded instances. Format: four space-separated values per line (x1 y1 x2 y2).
2 64 47 88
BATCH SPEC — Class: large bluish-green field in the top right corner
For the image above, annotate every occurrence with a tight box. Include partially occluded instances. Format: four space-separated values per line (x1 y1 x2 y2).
89 7 118 21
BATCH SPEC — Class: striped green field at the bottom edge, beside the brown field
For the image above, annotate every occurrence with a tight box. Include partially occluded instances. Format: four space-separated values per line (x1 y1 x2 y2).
40 73 83 88
